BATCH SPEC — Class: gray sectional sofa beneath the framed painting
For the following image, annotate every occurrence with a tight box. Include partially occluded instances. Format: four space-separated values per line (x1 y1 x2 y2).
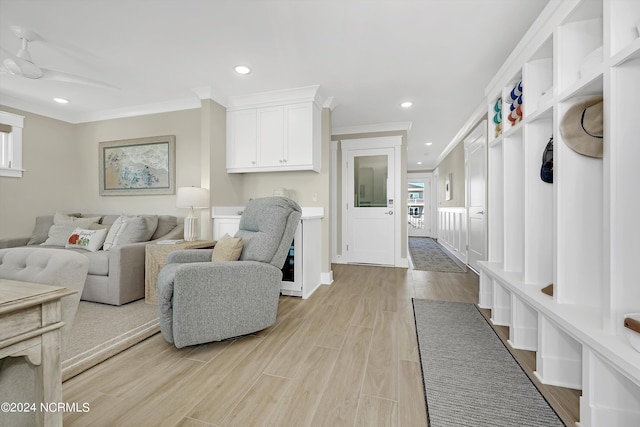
0 213 184 305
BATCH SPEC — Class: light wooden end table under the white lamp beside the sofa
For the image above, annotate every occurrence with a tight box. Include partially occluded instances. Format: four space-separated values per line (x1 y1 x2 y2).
144 240 216 304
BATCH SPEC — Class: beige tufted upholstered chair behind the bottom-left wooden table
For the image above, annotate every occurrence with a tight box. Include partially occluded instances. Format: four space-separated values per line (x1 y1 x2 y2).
0 247 89 427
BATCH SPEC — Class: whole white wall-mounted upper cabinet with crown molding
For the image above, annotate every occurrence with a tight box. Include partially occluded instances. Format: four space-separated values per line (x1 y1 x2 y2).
227 86 322 173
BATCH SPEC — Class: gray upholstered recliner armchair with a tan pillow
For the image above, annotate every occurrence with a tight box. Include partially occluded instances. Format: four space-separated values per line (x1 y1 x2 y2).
158 196 302 348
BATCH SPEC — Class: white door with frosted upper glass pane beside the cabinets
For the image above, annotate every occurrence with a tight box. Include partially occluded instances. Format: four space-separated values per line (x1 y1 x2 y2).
343 148 400 265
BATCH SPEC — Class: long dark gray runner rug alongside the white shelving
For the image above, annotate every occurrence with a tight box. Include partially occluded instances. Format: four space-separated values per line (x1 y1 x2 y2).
413 299 564 427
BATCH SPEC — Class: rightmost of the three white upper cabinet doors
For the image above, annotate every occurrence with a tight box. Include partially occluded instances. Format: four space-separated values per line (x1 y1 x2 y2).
283 102 313 166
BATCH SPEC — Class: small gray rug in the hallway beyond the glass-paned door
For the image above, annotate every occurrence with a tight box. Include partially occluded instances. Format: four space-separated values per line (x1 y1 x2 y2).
409 237 467 273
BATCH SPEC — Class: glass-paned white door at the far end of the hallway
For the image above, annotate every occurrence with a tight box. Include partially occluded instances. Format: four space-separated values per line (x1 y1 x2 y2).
407 173 432 241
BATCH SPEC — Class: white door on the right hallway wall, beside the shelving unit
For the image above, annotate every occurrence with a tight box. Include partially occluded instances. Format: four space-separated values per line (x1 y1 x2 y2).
465 121 487 271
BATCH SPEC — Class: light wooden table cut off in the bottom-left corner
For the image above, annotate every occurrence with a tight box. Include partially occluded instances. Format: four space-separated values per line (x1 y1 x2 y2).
0 279 76 426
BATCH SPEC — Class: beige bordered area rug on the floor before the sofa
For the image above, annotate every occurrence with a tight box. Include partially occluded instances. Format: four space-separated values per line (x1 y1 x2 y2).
62 299 160 380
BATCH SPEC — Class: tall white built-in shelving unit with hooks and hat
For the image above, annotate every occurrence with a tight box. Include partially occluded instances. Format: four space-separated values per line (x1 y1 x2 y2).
479 0 640 427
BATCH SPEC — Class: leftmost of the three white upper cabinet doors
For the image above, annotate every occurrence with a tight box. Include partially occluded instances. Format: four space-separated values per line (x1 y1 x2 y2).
227 109 258 169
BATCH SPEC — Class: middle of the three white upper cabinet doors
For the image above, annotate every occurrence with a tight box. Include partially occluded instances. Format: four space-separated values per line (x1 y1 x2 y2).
257 106 284 167
